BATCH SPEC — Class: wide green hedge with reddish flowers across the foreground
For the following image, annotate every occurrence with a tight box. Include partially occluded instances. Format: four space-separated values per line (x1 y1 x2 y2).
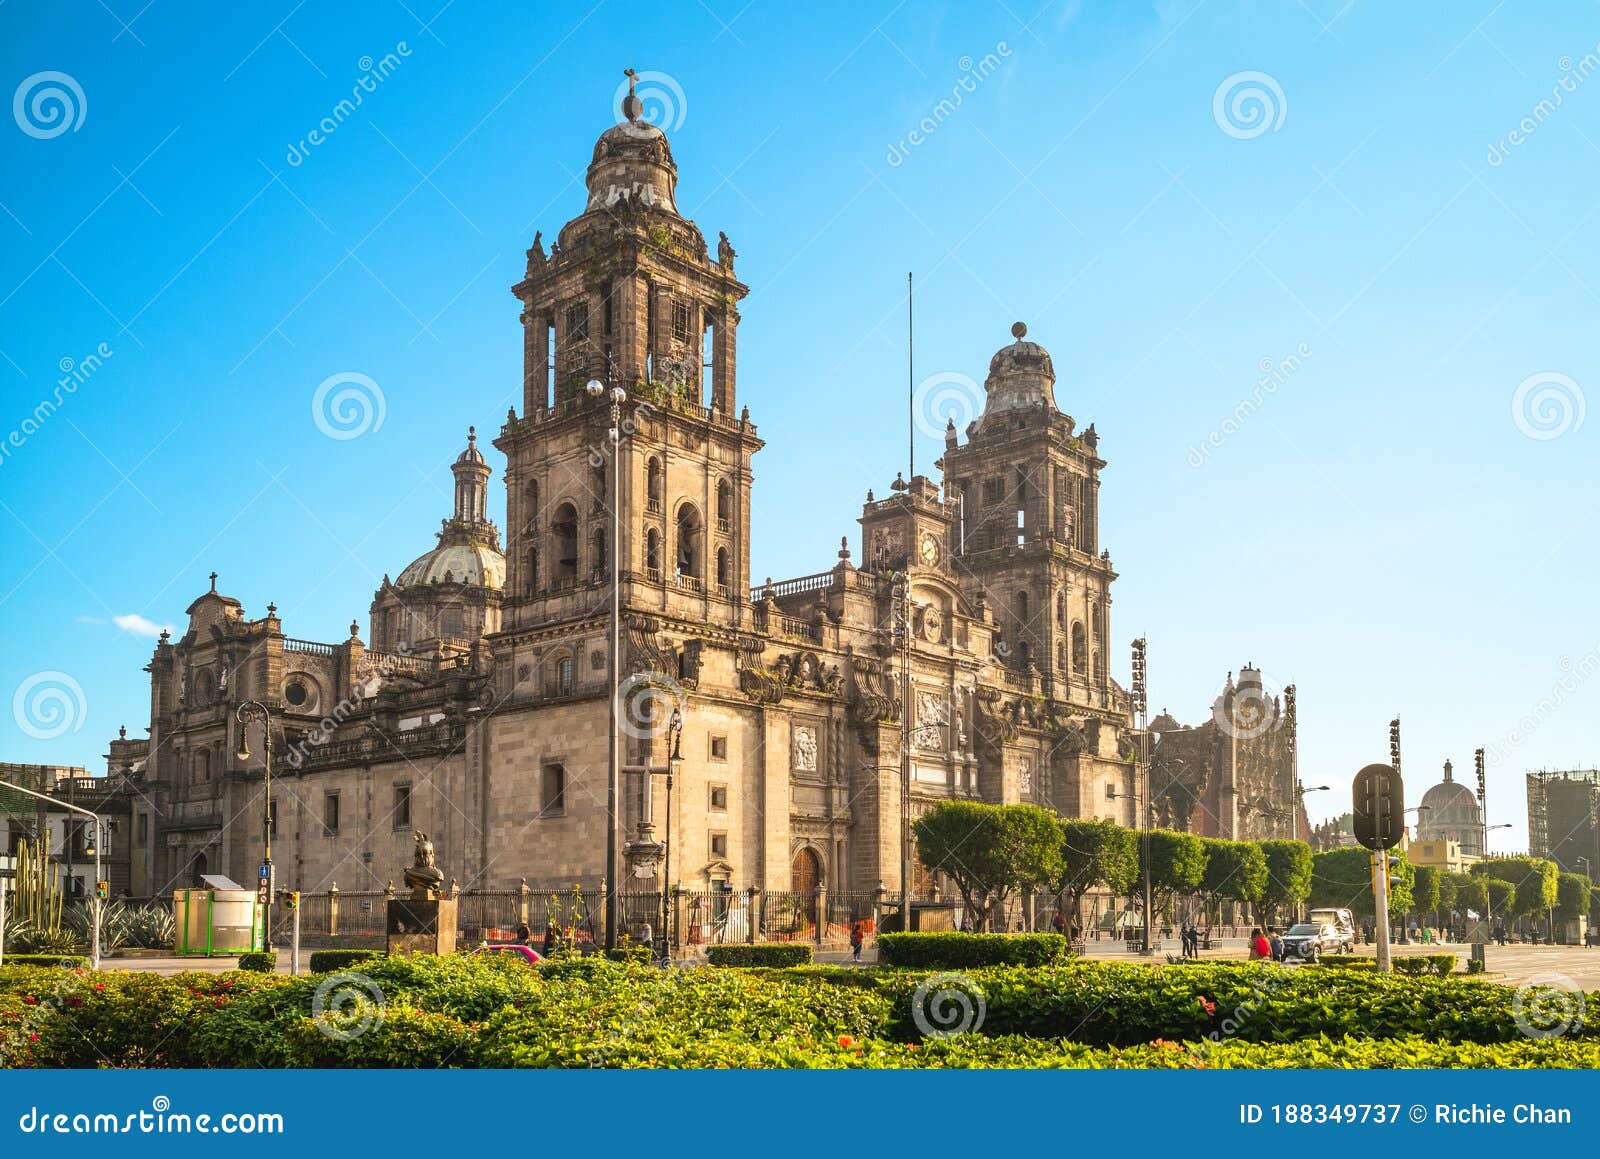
0 948 1600 1068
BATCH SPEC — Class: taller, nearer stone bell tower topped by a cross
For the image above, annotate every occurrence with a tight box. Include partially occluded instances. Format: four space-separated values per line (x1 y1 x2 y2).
494 70 762 643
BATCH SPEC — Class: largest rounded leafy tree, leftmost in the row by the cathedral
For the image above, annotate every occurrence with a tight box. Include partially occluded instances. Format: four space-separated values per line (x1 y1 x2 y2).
912 800 1061 928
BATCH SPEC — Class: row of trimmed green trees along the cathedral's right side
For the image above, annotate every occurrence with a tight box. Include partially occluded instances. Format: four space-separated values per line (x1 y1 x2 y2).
914 800 1594 927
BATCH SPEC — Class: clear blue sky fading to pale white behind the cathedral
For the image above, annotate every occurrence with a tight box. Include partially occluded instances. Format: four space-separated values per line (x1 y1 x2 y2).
0 0 1600 848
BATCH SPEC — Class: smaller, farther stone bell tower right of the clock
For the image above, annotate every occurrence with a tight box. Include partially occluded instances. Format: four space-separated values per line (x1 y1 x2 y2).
939 322 1117 708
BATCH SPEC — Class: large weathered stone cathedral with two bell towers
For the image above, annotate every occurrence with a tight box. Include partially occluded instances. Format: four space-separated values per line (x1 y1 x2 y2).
109 81 1293 895
